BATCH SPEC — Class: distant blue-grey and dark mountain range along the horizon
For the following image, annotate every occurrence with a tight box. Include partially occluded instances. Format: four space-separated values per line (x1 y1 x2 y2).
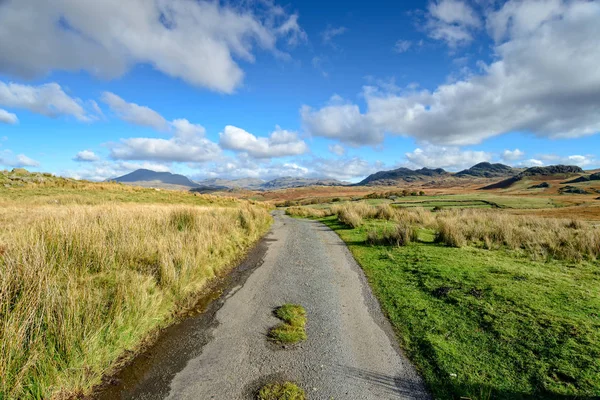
110 162 595 192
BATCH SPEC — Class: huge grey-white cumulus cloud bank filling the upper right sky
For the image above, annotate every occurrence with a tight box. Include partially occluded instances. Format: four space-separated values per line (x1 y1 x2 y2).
301 1 600 146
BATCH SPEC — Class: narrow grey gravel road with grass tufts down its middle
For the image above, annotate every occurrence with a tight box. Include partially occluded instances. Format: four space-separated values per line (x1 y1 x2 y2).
99 212 430 400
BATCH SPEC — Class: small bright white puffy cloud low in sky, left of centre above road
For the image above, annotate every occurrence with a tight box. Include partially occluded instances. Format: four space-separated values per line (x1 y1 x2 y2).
219 125 308 158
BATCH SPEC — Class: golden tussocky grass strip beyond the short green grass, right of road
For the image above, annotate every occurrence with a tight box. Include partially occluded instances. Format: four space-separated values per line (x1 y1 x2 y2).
288 202 600 261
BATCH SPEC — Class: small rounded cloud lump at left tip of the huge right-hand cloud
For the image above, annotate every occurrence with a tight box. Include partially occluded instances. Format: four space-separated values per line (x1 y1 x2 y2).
300 96 383 146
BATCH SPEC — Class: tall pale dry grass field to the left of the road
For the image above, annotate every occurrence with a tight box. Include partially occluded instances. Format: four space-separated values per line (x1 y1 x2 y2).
0 205 271 399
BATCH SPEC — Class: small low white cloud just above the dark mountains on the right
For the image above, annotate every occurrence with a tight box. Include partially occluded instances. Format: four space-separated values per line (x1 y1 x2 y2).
405 145 492 171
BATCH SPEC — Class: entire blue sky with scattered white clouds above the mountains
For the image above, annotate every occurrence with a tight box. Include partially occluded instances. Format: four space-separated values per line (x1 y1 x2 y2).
0 0 600 182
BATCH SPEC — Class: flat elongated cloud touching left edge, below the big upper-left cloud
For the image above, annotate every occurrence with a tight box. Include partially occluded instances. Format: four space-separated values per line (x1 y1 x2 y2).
0 79 94 122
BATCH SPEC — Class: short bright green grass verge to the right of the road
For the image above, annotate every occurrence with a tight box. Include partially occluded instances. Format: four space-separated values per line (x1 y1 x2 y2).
323 217 600 399
